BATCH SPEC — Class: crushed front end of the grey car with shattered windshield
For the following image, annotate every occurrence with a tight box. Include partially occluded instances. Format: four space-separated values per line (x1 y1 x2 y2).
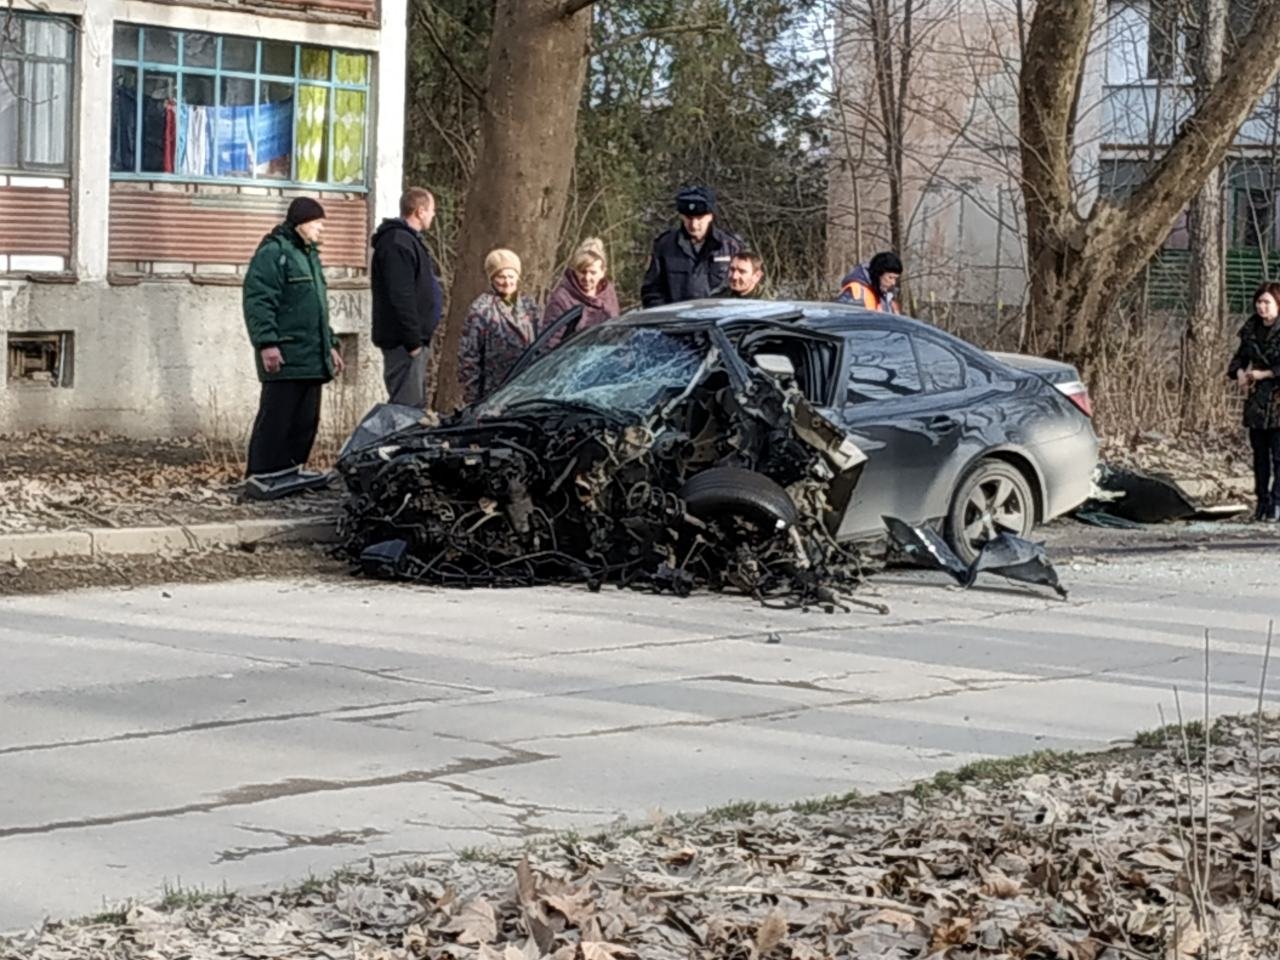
339 325 865 607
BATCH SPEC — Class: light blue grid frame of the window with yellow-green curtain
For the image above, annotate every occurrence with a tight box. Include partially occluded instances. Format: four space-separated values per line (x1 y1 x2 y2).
111 22 372 193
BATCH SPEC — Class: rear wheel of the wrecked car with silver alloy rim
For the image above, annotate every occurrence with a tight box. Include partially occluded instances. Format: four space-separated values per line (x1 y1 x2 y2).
946 460 1036 563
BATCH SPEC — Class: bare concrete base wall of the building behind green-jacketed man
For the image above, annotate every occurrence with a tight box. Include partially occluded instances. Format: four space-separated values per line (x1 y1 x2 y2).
0 283 381 440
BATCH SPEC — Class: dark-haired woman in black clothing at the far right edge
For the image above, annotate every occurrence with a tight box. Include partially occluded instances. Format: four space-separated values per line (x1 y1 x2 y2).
1226 283 1280 521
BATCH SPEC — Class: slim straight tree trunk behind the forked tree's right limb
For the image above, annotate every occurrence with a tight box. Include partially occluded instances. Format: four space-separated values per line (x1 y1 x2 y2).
1181 0 1226 433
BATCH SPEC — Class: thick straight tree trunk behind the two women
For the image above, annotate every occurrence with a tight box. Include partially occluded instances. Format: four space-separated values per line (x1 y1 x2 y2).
435 0 591 411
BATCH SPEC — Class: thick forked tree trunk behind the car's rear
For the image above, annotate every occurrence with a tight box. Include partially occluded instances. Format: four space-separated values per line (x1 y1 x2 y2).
1019 0 1280 376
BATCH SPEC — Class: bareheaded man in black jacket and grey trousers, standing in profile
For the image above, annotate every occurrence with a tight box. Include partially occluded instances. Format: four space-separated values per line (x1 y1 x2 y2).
370 187 442 407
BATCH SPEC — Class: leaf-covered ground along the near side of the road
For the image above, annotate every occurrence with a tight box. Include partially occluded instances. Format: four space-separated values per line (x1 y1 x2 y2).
0 716 1280 960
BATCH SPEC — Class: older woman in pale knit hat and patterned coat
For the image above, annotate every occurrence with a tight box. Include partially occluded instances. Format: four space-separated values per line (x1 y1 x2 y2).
458 247 543 403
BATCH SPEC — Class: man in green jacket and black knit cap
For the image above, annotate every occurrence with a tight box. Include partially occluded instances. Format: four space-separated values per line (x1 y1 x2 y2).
244 197 343 476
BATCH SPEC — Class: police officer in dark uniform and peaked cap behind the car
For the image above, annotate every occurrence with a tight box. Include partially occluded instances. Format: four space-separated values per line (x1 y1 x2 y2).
640 187 742 307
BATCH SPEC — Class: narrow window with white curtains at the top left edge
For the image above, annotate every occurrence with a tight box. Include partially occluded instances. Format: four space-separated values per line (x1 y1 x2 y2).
0 10 76 174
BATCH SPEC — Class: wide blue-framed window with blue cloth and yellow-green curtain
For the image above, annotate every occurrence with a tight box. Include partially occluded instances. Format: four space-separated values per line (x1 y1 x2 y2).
111 24 369 189
